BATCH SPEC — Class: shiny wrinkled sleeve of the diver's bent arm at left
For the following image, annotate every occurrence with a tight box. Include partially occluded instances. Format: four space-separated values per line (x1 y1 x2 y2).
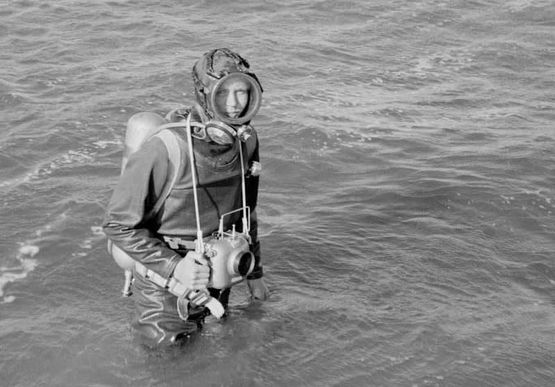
103 137 181 278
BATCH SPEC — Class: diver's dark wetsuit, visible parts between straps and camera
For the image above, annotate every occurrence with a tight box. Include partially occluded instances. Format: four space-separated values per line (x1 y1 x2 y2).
103 111 262 344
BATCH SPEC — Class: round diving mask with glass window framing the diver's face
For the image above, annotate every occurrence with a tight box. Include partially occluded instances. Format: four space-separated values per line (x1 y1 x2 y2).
210 73 262 125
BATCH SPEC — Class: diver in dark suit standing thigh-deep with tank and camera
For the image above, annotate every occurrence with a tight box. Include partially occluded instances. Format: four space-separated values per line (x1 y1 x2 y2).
103 48 268 345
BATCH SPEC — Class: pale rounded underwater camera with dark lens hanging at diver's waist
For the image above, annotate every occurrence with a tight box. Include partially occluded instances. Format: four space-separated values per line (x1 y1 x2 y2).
204 209 255 289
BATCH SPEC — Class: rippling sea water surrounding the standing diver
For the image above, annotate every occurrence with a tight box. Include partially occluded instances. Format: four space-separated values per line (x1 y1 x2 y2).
0 0 555 386
